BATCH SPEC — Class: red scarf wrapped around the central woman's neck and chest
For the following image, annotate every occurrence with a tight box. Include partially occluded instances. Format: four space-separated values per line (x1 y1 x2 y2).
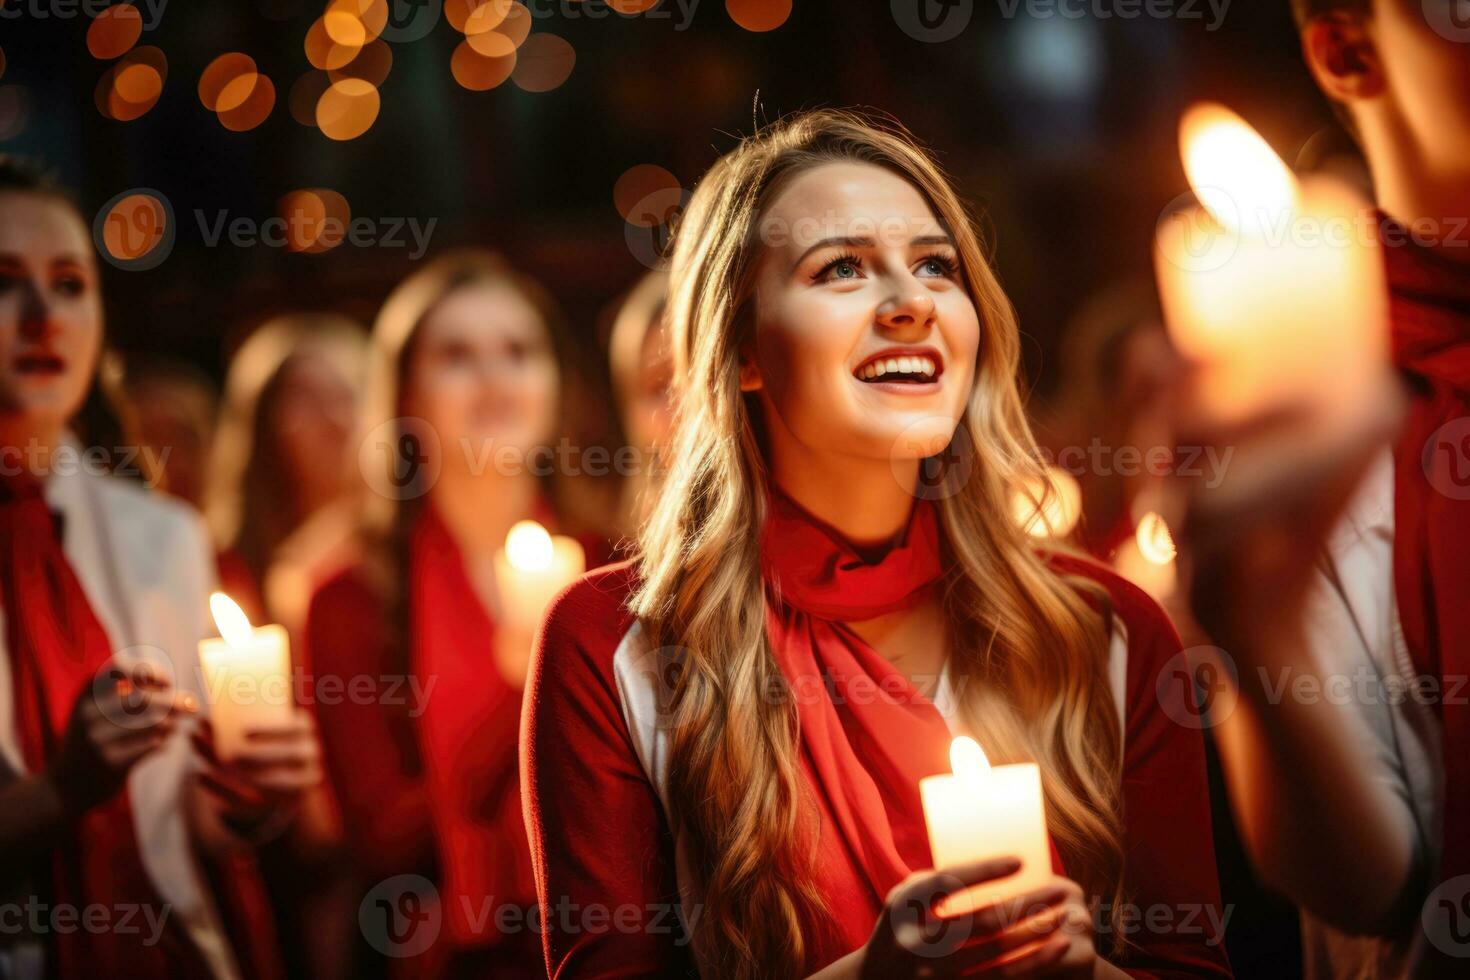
761 491 1061 967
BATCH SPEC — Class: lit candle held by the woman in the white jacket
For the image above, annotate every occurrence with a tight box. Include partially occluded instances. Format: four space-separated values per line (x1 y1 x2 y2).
198 592 295 761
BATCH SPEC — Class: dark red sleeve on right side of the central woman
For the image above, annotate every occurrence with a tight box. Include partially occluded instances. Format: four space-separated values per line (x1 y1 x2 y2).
1105 577 1232 979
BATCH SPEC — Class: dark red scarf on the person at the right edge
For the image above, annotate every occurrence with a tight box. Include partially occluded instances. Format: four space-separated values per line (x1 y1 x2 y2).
1382 216 1470 899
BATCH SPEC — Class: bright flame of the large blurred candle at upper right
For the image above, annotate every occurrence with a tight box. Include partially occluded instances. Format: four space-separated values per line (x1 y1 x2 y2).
1179 103 1297 231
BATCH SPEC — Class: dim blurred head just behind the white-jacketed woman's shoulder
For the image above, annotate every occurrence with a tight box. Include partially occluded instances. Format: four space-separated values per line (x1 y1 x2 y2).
122 357 219 510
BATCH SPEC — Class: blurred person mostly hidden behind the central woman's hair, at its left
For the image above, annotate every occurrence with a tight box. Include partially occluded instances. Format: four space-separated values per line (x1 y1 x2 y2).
607 270 673 538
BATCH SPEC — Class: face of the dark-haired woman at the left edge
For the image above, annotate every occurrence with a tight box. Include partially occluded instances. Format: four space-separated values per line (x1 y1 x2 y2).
0 192 101 443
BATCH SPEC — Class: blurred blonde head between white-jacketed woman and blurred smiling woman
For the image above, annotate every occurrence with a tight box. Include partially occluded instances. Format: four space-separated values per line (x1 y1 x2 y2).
204 313 366 633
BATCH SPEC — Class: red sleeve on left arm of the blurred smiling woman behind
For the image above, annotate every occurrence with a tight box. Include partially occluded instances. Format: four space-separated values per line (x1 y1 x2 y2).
304 570 435 876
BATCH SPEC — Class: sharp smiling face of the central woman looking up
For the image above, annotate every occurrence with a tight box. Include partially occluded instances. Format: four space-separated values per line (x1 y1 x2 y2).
741 162 980 467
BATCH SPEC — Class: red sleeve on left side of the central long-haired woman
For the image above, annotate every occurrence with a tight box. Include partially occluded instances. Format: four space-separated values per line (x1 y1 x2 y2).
520 563 695 980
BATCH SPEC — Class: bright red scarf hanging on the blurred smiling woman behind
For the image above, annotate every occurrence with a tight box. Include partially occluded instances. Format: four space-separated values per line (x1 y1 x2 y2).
409 507 545 957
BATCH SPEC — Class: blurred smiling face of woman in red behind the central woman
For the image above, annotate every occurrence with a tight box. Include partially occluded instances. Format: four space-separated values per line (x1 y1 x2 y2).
404 284 560 467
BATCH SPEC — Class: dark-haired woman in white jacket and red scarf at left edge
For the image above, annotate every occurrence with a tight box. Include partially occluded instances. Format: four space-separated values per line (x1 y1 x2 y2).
0 157 320 979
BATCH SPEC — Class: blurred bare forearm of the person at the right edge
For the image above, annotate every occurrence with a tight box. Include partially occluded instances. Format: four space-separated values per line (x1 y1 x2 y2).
1216 625 1416 934
